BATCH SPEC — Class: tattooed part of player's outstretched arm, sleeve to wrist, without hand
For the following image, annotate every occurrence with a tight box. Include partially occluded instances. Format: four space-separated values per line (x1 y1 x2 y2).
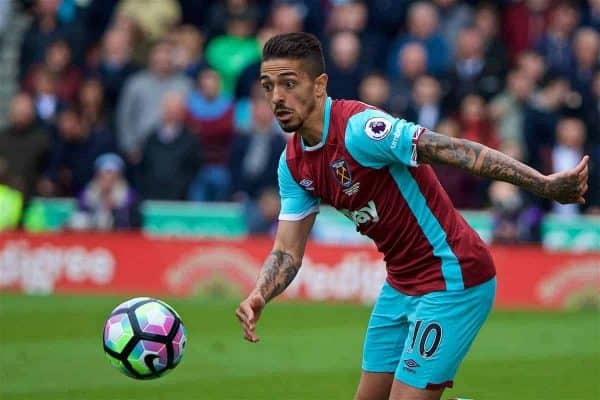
417 131 546 195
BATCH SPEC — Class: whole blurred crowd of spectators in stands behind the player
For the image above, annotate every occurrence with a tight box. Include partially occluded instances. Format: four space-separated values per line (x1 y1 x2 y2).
0 0 600 242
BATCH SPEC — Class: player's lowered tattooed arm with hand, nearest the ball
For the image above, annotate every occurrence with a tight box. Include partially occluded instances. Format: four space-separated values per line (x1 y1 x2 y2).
236 214 316 342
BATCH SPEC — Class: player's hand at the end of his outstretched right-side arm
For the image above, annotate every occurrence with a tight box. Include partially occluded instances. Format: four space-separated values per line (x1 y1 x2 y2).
543 156 590 204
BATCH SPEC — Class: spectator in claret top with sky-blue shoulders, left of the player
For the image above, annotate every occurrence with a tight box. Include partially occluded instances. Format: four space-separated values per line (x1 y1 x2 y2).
187 68 234 201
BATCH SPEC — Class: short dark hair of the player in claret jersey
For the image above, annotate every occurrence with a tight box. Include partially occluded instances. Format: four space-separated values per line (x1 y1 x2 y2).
262 32 325 78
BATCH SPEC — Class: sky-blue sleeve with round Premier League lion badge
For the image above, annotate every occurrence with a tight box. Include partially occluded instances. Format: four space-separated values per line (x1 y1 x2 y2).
345 109 424 169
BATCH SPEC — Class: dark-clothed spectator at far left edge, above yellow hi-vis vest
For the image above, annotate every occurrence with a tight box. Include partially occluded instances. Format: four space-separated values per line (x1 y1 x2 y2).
0 93 50 200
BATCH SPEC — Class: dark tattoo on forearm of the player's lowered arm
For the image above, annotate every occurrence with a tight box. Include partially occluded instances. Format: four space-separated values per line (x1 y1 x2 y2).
256 250 300 302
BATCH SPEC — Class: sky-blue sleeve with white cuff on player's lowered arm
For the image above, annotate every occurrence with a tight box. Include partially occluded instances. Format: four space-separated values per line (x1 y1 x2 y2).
277 149 319 221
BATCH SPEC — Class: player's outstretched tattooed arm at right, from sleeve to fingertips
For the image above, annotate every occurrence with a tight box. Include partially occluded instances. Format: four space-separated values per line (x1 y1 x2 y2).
417 131 589 204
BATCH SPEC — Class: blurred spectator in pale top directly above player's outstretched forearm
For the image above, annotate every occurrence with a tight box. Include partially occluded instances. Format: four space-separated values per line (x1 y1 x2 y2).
489 69 535 154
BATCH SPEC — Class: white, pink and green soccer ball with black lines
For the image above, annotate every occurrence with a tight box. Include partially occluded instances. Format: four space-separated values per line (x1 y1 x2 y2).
102 297 186 379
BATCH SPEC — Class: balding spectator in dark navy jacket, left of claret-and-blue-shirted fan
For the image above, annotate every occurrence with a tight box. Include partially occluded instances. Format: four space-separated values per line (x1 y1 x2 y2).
140 92 202 200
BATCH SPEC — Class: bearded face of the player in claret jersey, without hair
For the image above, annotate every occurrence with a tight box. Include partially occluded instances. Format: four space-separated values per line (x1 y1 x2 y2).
260 58 316 132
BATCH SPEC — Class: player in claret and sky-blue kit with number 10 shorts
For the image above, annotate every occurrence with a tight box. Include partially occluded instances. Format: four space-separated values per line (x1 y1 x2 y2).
236 33 588 400
